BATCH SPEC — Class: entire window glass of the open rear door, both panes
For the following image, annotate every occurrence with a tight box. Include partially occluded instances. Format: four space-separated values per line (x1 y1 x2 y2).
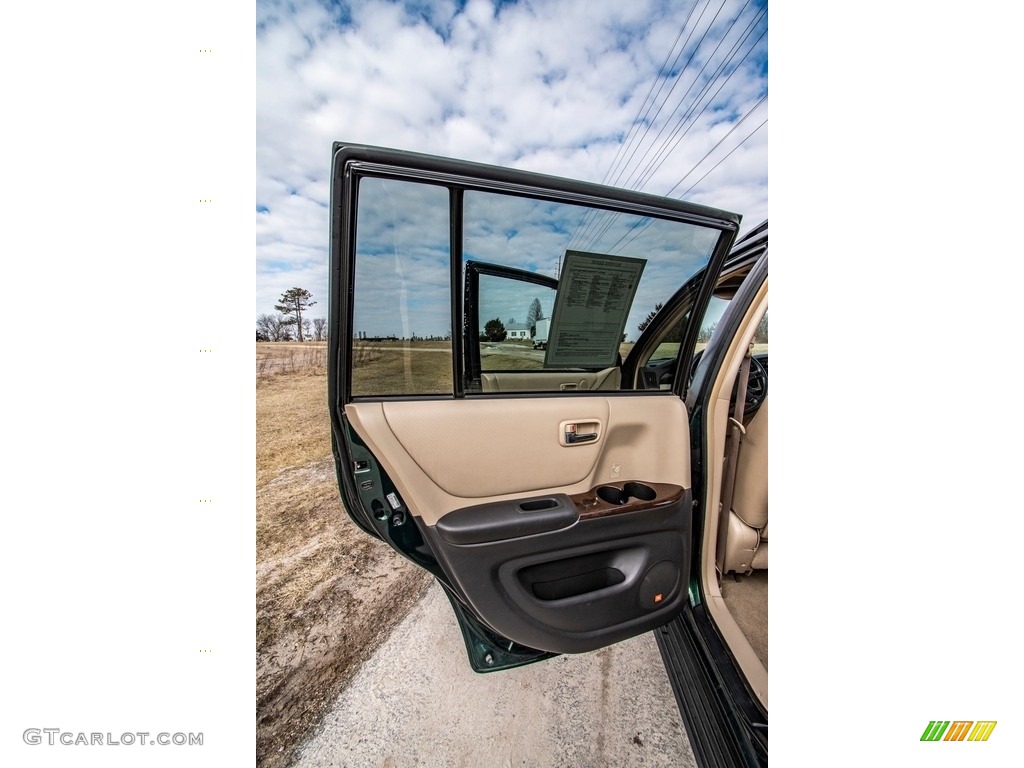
348 174 721 397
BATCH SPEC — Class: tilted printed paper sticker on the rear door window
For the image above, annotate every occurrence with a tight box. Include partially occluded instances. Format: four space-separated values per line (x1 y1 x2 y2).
544 251 647 368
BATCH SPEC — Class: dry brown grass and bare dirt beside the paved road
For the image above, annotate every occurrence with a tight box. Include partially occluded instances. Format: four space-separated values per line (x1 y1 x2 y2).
256 344 429 768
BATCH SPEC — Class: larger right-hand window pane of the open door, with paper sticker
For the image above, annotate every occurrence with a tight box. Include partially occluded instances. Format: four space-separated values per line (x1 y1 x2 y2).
463 190 718 391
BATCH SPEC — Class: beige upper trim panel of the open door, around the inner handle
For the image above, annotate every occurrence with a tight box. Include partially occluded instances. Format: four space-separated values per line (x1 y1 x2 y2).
345 395 690 525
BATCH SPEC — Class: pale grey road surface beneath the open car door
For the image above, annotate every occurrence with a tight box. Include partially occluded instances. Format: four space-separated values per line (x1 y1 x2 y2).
295 584 694 768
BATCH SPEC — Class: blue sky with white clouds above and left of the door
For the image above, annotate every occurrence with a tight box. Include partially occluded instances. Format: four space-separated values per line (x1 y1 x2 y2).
255 0 768 316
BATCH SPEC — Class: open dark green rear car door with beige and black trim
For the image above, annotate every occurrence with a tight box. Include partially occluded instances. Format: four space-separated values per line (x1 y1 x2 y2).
329 143 739 672
